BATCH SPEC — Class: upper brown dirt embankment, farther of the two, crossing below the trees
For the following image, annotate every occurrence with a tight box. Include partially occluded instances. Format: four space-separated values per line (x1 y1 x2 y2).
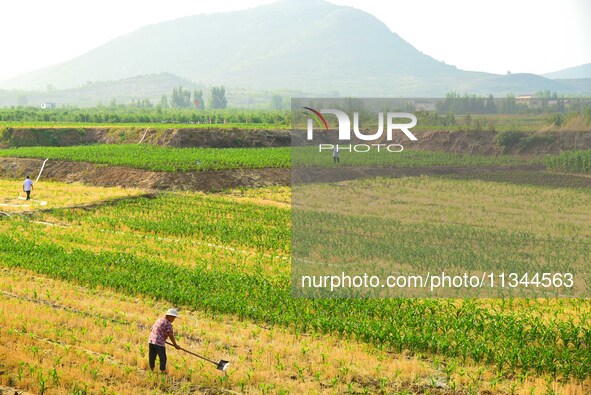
0 128 591 155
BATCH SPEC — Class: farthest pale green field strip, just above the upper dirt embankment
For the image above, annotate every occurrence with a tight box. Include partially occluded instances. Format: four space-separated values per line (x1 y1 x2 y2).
0 108 591 135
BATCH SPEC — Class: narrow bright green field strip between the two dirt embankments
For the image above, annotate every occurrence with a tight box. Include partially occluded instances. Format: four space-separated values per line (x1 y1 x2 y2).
0 144 544 172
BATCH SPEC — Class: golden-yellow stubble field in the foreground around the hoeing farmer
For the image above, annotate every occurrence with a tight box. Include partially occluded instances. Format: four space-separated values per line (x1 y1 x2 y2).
0 269 591 395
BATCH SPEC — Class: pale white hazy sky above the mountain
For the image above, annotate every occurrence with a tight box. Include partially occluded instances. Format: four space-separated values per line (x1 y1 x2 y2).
0 0 591 80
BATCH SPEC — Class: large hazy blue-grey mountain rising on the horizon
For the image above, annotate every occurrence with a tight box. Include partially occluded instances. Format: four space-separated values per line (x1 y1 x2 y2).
0 0 589 100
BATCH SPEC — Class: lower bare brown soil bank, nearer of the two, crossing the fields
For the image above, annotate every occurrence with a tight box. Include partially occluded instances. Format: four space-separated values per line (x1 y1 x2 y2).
0 158 591 192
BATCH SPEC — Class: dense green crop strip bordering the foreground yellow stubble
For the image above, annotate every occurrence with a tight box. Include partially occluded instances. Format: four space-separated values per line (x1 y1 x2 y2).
0 234 591 378
